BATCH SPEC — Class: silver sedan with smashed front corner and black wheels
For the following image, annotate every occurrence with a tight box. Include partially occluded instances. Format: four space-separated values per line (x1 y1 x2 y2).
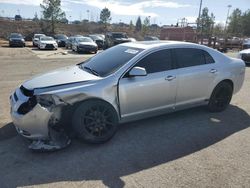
10 41 245 150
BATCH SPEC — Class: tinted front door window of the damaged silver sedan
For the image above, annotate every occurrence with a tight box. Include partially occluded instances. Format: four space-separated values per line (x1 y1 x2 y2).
135 50 172 74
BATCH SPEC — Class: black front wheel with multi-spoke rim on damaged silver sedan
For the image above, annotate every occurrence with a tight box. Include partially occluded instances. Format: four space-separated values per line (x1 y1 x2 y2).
72 100 118 144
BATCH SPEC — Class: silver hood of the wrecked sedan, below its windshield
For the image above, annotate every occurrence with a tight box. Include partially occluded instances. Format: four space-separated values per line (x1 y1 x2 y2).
23 65 100 90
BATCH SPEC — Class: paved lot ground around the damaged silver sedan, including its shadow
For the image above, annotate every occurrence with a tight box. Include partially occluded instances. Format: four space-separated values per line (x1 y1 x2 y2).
0 47 250 187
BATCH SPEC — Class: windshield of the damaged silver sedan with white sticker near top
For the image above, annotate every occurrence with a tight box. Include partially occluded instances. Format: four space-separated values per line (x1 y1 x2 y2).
80 46 143 77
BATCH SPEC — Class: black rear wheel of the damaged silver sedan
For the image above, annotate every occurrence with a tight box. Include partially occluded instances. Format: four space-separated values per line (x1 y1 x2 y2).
208 82 233 112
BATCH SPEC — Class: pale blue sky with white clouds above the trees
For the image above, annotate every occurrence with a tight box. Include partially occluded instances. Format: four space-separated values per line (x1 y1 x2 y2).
0 0 250 25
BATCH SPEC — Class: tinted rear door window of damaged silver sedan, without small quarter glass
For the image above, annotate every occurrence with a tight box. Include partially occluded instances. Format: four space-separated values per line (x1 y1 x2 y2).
174 48 206 68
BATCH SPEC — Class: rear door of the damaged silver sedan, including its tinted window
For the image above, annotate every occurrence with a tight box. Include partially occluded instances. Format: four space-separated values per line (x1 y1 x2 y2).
174 48 218 107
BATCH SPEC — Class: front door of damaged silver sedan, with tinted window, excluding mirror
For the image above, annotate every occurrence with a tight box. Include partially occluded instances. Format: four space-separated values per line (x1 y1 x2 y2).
119 50 177 117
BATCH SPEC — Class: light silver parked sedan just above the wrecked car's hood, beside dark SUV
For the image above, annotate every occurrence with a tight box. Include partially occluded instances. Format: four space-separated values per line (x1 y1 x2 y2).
72 37 98 53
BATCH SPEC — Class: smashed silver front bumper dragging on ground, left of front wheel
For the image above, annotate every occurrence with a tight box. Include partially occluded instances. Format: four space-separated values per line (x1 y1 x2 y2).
10 86 70 150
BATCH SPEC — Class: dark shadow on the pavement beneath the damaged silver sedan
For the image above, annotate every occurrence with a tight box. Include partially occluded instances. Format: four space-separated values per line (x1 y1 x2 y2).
0 105 250 188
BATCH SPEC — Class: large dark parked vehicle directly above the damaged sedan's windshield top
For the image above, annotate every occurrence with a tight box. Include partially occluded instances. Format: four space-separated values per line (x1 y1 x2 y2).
105 32 130 48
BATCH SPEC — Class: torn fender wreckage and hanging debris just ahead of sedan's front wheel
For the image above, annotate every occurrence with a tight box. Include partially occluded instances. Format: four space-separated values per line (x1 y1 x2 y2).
29 95 71 151
